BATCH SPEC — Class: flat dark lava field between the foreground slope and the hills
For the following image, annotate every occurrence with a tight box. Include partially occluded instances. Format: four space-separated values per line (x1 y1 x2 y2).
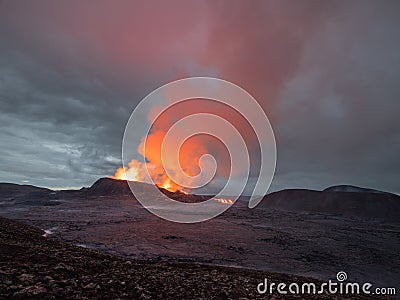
0 196 400 288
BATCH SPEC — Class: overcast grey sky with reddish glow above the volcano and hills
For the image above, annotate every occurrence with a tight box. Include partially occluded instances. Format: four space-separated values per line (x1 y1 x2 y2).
0 0 400 193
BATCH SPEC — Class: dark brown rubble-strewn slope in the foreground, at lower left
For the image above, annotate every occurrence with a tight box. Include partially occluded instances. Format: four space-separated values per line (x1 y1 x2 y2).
0 218 382 299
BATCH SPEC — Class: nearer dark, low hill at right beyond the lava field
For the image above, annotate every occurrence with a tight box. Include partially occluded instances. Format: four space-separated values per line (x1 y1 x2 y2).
258 189 400 221
